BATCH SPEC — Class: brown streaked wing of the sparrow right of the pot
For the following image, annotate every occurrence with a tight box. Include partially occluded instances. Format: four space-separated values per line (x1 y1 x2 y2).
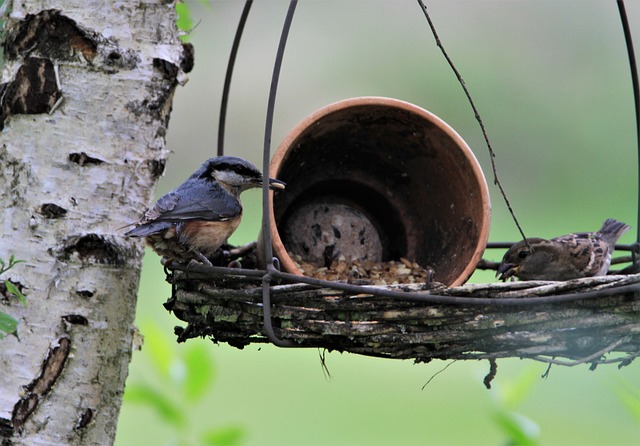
552 232 611 277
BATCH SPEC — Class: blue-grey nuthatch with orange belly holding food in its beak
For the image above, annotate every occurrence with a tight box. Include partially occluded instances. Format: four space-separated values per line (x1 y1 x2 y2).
125 156 285 265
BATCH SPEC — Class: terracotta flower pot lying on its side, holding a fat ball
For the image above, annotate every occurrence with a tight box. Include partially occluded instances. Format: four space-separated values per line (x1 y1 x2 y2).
270 97 490 286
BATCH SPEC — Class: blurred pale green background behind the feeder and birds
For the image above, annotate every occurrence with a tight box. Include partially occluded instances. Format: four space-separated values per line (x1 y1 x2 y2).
116 0 640 446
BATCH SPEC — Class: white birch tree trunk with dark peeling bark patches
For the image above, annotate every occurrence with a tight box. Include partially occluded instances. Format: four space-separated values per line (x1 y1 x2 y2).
0 0 192 445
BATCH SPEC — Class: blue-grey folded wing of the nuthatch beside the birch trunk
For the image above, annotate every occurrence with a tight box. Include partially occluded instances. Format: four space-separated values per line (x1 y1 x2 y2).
126 179 242 237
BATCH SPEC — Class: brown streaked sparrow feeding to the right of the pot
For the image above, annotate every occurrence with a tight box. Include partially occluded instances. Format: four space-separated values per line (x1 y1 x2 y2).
496 218 630 280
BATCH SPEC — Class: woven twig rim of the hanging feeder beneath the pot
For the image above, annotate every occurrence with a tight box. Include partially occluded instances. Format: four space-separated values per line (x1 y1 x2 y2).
165 271 640 366
